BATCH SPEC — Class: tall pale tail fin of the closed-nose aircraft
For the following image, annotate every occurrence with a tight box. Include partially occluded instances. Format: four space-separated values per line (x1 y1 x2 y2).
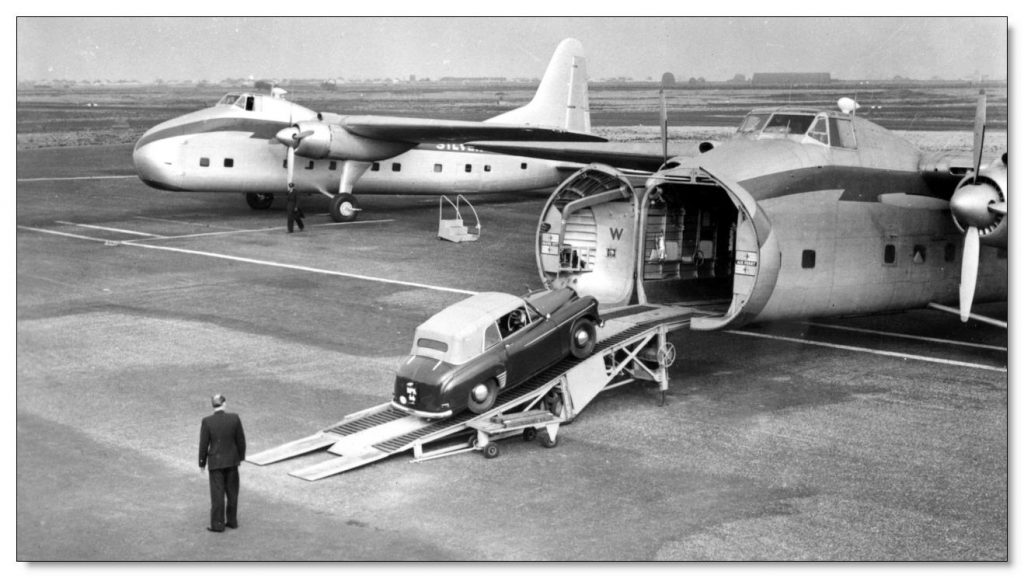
484 38 590 132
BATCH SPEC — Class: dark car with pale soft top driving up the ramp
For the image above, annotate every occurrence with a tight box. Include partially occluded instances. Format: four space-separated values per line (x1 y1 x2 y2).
391 288 603 419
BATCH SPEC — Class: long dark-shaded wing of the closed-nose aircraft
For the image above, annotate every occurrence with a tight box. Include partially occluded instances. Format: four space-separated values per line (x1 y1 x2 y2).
340 116 607 142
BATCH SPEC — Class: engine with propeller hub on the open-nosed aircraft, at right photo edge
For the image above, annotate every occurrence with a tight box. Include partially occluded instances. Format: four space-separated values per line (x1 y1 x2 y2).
949 162 1010 248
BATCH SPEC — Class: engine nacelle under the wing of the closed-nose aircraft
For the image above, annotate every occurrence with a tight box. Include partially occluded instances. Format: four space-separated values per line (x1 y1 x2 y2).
295 121 416 162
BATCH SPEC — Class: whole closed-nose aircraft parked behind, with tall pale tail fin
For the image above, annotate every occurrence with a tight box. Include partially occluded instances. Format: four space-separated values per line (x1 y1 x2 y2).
133 38 604 221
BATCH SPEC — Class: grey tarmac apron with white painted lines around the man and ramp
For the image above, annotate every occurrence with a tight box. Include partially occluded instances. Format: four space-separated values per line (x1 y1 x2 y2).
16 147 1009 562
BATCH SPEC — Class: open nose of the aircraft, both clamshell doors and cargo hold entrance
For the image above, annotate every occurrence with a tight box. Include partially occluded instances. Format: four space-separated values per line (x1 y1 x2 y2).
537 165 781 329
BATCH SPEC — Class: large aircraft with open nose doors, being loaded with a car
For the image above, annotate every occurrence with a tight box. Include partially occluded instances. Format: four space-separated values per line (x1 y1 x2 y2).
477 96 1008 329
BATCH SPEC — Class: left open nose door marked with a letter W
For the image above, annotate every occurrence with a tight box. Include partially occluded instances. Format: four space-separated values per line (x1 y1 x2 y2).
537 165 640 308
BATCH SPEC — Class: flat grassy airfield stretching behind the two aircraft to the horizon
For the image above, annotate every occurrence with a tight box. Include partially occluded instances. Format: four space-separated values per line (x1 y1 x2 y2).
16 84 1007 152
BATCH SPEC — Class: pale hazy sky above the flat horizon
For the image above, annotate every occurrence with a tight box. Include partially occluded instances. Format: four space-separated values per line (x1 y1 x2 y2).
16 11 1012 82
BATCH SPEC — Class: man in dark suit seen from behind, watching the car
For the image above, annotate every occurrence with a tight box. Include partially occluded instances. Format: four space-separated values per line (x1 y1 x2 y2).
199 394 246 532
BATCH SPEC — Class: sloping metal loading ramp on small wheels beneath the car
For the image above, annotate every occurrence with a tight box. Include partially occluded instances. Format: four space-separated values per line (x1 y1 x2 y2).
246 306 694 482
